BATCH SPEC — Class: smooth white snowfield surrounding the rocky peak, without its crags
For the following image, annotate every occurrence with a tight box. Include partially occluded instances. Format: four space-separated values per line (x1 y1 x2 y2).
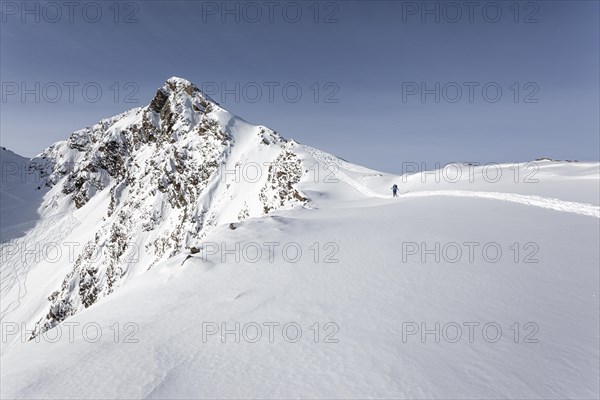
0 79 600 399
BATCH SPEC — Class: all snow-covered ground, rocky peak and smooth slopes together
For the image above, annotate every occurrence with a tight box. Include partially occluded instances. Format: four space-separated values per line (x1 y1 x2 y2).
0 78 600 399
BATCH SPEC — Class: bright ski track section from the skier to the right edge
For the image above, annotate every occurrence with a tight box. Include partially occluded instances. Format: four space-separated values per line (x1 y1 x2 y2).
400 190 600 218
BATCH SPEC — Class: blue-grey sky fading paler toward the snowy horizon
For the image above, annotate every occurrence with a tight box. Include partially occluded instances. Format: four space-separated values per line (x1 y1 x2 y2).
0 1 600 173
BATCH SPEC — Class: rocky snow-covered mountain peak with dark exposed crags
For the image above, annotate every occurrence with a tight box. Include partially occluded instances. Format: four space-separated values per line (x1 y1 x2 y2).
2 77 318 335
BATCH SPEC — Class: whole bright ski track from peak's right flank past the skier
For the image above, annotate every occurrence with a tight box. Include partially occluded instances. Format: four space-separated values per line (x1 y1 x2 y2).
304 146 600 218
